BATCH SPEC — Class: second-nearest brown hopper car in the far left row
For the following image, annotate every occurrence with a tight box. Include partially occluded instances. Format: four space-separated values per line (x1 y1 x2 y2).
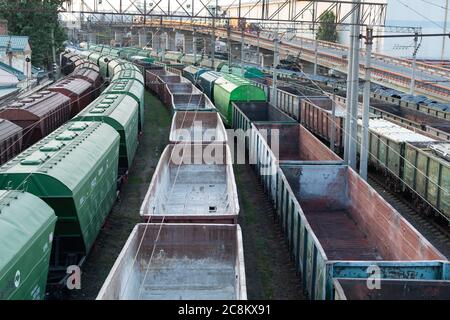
0 90 71 148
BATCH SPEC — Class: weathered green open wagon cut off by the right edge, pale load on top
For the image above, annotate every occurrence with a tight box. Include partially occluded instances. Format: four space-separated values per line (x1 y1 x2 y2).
404 142 450 221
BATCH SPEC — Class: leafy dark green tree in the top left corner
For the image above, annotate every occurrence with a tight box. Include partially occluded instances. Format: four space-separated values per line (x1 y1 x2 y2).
0 0 67 68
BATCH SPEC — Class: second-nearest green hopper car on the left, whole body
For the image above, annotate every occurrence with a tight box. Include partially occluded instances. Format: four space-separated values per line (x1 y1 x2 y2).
0 122 120 271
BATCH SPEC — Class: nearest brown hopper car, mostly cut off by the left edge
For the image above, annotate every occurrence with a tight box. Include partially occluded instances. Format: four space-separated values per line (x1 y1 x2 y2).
0 119 23 165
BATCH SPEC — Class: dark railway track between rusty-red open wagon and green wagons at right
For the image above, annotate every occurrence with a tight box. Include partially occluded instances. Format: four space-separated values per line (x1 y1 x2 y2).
368 173 450 257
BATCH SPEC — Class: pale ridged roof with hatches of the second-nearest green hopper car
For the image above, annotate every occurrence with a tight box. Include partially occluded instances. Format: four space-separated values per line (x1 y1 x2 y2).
0 122 119 197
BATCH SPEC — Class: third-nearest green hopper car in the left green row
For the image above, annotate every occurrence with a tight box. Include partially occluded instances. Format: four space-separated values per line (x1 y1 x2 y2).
72 94 139 169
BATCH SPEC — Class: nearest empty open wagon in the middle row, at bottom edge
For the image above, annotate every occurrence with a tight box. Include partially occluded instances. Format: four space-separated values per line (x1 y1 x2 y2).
97 224 247 300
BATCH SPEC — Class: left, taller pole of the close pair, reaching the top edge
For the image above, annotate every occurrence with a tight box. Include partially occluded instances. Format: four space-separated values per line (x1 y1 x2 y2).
346 0 361 170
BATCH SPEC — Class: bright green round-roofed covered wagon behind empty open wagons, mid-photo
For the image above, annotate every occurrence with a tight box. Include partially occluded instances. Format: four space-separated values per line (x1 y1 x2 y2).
214 74 266 125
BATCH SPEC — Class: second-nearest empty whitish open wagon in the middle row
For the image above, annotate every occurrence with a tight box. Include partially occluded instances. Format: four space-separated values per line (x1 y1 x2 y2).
140 143 239 223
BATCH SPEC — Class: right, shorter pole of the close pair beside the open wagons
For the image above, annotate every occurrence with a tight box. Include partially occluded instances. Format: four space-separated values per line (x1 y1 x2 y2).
359 27 373 181
